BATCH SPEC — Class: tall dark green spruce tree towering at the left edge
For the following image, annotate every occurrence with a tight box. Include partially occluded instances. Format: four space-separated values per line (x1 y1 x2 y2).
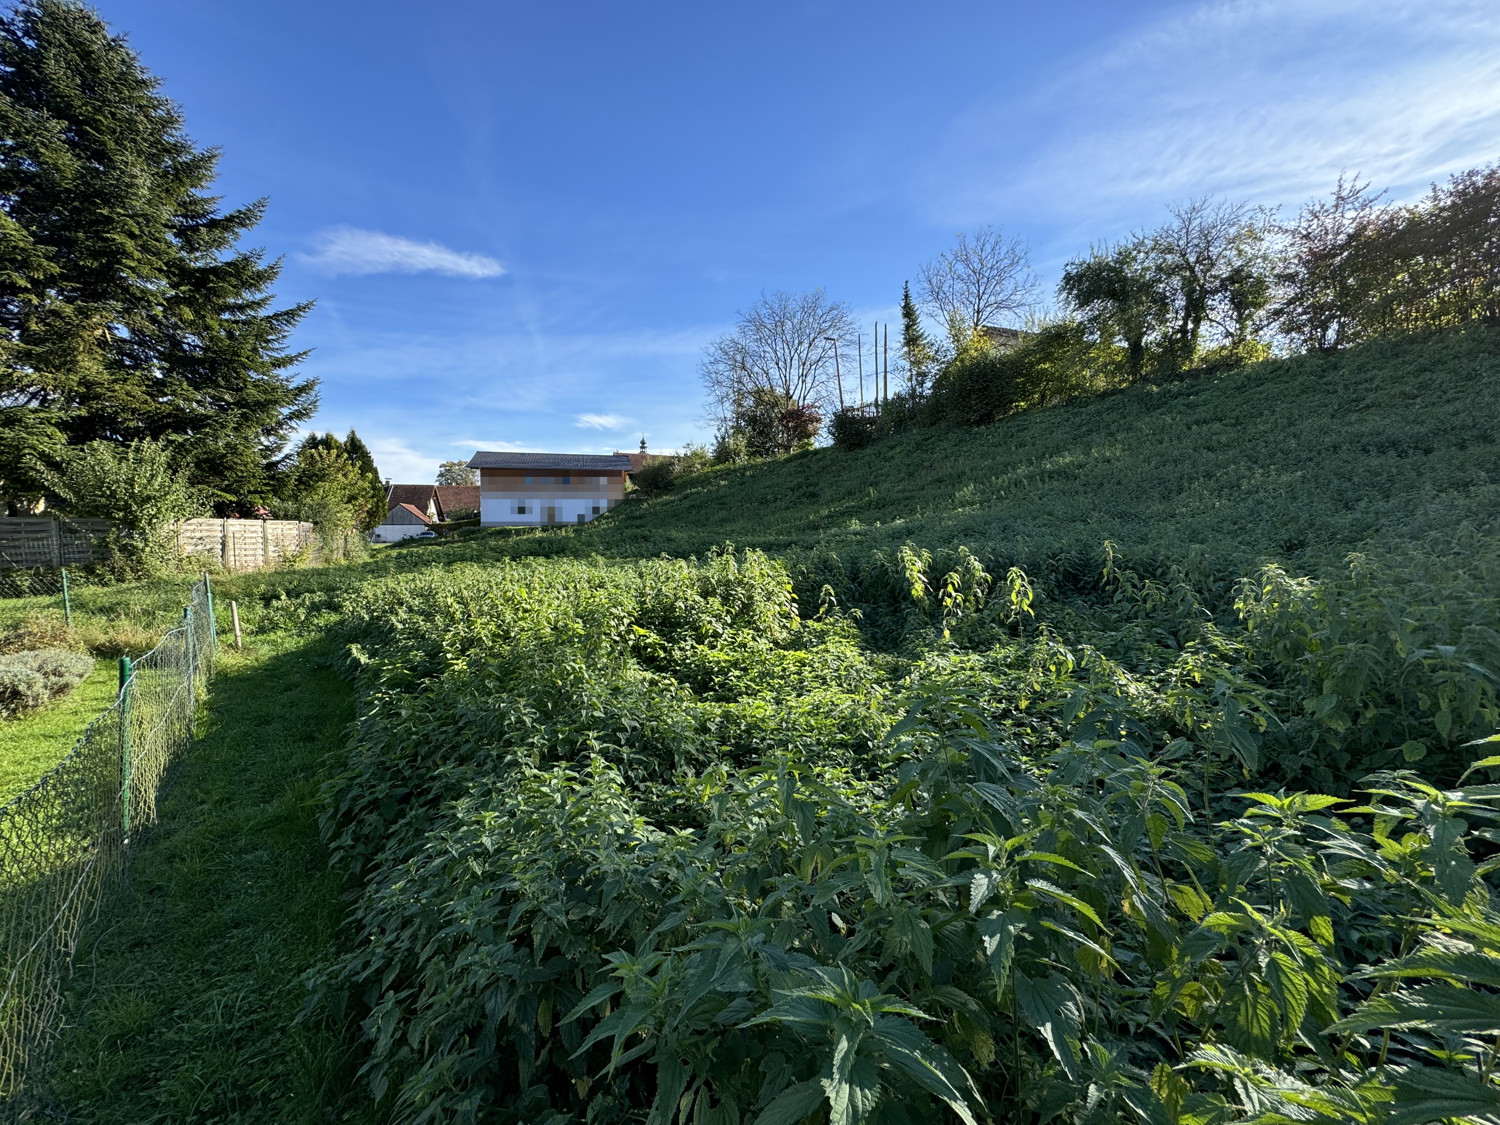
0 0 317 509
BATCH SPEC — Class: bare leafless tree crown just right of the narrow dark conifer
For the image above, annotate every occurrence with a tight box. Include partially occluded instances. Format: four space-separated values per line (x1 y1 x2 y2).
920 227 1037 342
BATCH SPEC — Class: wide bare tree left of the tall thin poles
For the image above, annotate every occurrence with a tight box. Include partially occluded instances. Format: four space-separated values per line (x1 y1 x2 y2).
699 290 854 425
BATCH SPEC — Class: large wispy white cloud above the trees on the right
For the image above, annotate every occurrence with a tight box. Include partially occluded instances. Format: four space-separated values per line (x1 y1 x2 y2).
921 0 1500 237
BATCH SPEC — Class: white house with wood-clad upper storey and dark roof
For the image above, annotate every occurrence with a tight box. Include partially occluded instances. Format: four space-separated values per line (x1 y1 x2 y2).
470 452 630 528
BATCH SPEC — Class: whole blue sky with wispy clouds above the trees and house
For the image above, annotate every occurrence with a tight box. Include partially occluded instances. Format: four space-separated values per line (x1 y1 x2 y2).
99 0 1500 482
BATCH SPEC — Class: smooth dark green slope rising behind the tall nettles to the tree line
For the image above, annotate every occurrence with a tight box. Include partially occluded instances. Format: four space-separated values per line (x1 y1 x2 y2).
459 330 1500 570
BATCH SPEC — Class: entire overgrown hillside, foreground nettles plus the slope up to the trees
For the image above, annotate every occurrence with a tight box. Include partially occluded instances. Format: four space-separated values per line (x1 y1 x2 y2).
175 330 1500 1125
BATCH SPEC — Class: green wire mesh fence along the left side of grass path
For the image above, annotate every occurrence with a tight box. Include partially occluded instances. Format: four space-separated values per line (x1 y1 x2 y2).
0 578 216 1121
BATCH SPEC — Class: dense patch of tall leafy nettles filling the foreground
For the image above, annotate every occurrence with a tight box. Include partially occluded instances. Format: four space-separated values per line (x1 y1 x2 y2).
317 546 1500 1125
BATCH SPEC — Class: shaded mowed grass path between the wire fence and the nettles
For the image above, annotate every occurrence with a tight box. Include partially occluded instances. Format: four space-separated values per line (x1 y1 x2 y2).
51 638 378 1125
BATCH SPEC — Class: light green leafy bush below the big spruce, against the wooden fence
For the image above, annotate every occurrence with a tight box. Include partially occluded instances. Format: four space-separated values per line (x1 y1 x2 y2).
48 440 207 576
